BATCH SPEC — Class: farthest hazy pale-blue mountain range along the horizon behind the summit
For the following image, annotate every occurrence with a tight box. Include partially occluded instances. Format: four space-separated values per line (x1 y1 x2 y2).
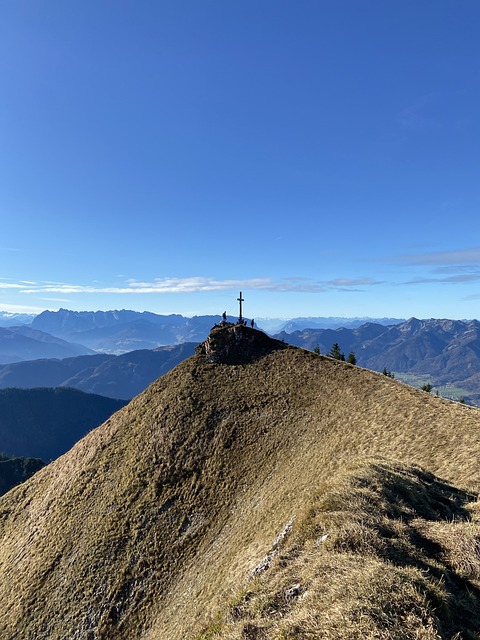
0 309 401 363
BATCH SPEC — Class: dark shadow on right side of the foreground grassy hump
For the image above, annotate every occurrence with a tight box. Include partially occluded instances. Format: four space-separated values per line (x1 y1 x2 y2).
366 464 480 640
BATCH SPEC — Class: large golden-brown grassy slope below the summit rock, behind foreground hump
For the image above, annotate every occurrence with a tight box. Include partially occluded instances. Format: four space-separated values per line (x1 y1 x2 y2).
0 330 480 640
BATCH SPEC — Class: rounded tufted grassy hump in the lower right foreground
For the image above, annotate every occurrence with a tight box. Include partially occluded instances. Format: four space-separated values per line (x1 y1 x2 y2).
197 459 480 640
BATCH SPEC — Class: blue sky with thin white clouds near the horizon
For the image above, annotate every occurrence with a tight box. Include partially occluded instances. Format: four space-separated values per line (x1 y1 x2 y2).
0 0 480 318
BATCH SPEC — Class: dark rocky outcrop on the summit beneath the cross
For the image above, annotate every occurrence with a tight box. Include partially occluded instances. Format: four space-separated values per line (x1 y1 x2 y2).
196 322 288 364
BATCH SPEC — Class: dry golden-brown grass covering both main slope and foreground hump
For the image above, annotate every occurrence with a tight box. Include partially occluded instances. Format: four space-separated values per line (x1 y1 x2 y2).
0 328 480 640
